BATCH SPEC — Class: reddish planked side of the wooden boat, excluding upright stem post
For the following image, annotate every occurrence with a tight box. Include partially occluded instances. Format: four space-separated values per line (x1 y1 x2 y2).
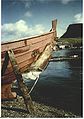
1 32 54 84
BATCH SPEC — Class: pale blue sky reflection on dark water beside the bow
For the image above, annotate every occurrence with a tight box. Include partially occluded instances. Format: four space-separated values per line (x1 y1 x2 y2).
41 61 71 78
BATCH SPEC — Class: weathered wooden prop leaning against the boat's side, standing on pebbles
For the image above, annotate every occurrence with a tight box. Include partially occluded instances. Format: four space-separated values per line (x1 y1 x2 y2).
7 50 34 113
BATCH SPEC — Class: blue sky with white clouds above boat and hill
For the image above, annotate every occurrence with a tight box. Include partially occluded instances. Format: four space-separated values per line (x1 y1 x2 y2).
1 0 82 42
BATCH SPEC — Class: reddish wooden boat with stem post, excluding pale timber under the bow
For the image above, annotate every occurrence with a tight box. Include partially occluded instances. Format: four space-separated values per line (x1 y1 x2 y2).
1 20 56 98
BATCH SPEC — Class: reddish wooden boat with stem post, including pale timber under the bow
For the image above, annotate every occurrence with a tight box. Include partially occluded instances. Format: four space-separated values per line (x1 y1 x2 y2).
1 20 56 99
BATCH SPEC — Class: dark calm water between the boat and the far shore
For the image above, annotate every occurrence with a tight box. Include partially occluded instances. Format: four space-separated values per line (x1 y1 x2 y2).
26 49 82 116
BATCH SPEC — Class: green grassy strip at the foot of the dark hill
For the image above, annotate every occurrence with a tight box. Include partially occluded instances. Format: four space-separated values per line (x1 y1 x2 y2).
58 38 82 46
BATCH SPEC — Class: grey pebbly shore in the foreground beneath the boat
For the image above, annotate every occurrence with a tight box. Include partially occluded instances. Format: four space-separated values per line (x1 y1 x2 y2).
1 96 77 118
